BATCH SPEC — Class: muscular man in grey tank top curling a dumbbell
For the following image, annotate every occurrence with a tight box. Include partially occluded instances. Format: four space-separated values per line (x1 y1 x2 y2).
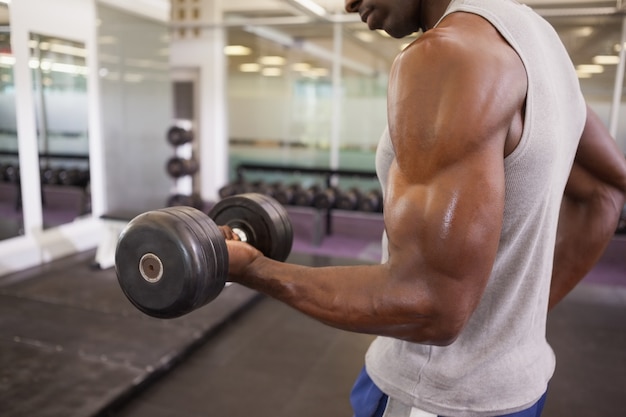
222 0 626 417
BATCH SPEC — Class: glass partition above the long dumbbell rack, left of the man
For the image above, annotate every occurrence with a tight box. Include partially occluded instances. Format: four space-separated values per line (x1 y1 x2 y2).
226 23 407 191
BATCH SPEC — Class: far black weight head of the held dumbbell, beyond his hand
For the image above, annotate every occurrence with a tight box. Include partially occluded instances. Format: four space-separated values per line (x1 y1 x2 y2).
209 193 293 262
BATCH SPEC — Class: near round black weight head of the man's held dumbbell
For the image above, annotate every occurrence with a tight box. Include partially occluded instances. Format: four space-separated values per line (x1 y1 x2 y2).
115 207 228 318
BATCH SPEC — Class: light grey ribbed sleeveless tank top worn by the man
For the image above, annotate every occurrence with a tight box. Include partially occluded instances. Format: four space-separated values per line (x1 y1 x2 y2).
366 0 586 417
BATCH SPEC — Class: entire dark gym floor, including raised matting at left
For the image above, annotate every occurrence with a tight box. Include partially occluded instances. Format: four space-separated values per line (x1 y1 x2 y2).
0 210 626 417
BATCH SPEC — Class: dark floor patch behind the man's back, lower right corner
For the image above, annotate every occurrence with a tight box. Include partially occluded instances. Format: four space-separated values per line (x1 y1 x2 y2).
543 284 626 417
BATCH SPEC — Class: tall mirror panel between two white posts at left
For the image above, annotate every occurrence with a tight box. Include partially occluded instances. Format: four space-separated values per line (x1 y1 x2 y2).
29 33 91 228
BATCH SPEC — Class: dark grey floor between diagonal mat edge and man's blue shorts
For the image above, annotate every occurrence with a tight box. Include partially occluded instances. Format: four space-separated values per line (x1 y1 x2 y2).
110 299 371 417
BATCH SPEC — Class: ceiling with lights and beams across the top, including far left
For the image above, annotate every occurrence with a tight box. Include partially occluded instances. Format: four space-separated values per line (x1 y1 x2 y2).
0 0 622 94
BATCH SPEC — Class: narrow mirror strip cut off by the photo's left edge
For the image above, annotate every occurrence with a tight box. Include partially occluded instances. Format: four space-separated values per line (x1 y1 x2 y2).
0 3 23 240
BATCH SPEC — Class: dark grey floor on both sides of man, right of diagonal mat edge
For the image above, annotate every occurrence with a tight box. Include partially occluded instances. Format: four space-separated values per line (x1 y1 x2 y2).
103 284 626 417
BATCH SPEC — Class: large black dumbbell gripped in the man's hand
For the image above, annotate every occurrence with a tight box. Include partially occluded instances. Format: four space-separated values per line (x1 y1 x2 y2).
115 193 293 318
